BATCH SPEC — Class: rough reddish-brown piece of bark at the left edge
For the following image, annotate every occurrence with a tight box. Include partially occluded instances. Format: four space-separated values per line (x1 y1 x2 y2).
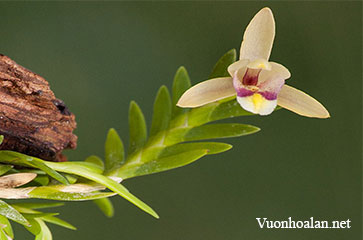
0 54 77 161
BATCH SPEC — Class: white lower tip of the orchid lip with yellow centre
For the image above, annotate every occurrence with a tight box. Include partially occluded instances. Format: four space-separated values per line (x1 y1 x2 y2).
237 93 277 115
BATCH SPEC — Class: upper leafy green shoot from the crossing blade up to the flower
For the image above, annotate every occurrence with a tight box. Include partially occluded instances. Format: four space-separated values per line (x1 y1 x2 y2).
106 50 259 179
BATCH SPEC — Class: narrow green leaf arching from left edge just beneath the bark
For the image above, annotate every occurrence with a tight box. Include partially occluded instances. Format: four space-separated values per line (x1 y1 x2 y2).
0 150 69 185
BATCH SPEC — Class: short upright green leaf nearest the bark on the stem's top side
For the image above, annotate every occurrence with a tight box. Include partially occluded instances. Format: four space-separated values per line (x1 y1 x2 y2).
105 128 125 173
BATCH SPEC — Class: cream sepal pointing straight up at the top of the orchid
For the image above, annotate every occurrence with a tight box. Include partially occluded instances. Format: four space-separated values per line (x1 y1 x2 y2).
240 7 275 61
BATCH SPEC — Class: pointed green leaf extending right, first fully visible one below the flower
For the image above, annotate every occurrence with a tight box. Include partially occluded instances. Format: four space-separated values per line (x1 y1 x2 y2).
184 123 260 141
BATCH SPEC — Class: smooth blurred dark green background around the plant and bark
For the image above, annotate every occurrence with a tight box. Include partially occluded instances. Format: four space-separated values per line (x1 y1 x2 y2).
0 2 362 240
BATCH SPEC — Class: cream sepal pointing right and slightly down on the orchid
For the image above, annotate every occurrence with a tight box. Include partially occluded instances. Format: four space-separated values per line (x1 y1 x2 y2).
277 84 330 118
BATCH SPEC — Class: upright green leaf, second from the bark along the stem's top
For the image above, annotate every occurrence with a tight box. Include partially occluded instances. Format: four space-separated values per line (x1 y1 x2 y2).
129 101 147 154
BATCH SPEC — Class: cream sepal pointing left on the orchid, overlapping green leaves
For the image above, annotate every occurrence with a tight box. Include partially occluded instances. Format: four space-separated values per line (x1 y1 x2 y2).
177 77 236 108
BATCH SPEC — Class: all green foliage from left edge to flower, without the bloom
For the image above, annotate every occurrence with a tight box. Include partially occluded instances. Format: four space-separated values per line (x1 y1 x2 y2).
0 49 268 239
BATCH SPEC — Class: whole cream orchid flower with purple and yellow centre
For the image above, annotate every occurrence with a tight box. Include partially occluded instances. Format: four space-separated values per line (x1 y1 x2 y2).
177 8 330 118
